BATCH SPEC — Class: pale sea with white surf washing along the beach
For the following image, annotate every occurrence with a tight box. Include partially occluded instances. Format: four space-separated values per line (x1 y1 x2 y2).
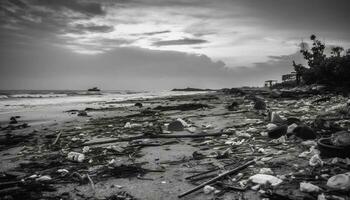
0 90 205 126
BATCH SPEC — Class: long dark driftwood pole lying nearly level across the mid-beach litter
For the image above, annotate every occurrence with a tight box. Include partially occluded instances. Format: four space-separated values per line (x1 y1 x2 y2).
83 132 224 146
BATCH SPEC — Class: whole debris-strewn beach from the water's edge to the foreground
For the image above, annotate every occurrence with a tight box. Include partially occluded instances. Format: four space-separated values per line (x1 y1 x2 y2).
0 89 350 200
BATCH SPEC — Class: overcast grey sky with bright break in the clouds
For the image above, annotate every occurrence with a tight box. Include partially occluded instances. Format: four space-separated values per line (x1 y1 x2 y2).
0 0 350 90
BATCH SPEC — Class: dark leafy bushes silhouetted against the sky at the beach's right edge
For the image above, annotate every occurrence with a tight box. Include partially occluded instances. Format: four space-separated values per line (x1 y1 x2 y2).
293 35 350 88
